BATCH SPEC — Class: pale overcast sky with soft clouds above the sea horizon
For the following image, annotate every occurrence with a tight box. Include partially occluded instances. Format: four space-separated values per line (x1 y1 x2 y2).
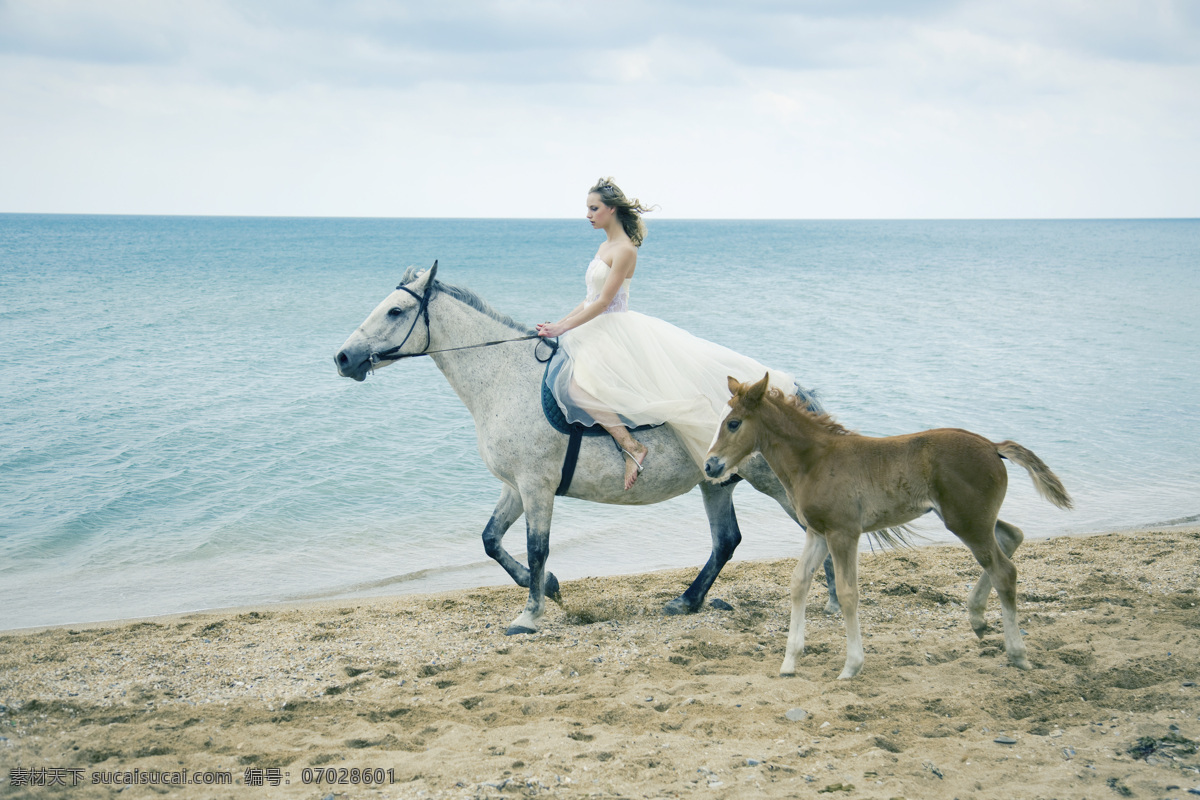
0 0 1200 218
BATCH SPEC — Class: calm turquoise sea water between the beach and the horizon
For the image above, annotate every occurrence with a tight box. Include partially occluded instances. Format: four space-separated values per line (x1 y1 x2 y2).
0 215 1200 628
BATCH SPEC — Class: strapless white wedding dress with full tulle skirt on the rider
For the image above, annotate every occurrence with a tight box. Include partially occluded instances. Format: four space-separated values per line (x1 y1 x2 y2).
548 258 796 467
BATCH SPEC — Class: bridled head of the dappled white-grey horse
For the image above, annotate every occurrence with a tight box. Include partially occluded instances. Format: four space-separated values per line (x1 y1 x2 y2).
334 261 438 380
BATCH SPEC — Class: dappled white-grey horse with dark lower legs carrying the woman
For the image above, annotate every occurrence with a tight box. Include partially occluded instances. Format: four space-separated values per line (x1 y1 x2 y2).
334 261 864 634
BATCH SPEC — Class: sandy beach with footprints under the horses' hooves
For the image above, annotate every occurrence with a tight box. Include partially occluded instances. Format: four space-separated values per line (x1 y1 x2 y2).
0 528 1200 800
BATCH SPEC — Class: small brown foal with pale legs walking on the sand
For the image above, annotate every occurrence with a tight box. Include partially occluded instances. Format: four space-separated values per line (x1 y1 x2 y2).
704 378 1072 680
